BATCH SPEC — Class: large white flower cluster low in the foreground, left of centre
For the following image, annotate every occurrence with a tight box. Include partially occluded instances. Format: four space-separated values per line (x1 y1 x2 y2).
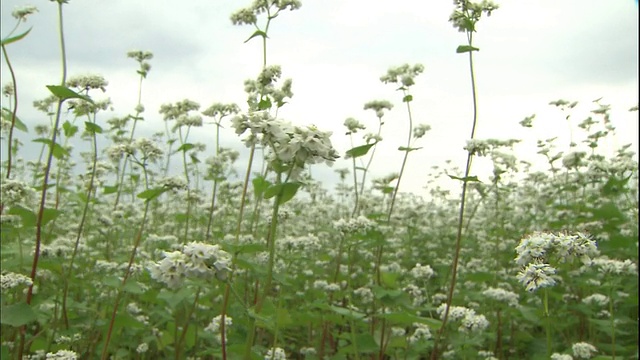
148 242 231 288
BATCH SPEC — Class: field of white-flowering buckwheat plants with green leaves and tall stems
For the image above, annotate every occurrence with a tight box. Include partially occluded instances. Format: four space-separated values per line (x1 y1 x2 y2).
0 0 638 360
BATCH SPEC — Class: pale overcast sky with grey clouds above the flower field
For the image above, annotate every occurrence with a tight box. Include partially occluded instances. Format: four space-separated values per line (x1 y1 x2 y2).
0 0 638 195
